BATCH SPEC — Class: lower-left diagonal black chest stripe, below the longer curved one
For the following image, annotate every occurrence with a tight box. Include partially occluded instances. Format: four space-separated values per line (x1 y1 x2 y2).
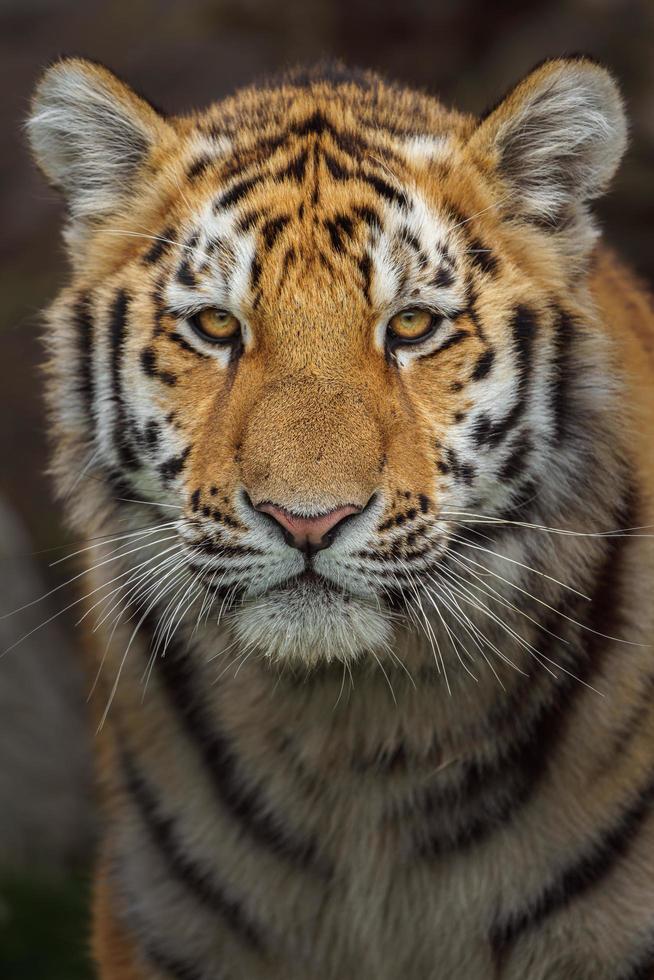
121 751 264 950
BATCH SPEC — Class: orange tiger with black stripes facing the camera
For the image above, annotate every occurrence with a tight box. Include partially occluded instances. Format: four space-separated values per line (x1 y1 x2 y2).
27 56 654 980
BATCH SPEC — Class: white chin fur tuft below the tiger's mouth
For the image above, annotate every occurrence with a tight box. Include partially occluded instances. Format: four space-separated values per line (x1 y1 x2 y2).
230 585 392 666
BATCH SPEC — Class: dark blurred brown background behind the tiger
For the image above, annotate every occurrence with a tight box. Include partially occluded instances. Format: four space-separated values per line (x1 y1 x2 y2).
0 0 654 980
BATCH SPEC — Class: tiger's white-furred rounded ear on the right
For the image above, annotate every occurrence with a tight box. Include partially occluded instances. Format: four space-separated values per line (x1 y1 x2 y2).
470 58 627 235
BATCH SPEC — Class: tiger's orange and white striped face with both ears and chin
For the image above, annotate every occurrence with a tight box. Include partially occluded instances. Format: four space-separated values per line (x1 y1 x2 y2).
30 60 625 663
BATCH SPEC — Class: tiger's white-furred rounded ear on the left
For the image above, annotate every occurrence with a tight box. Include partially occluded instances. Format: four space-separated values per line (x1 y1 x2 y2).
27 58 171 220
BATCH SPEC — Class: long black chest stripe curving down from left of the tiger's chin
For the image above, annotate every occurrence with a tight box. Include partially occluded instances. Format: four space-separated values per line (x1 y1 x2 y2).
146 616 329 876
